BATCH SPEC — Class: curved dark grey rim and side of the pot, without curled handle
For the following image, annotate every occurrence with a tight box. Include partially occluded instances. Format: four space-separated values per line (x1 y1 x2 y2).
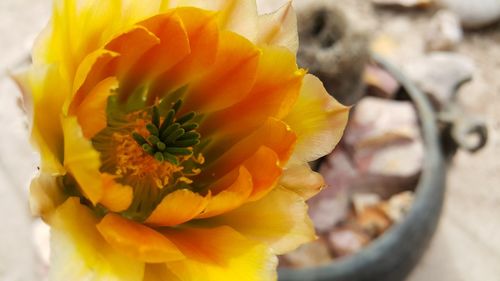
279 55 446 281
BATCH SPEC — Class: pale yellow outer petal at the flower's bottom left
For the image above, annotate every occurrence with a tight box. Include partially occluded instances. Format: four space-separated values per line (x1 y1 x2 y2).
49 198 144 281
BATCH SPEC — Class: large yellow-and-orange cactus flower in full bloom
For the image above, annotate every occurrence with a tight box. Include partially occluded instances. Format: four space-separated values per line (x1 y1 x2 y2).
17 0 348 281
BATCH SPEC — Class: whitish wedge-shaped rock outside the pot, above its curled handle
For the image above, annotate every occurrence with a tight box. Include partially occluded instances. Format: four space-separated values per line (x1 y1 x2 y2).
403 52 475 109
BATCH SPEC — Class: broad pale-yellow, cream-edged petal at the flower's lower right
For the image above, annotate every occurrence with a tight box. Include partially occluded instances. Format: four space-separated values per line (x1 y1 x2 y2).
211 187 316 254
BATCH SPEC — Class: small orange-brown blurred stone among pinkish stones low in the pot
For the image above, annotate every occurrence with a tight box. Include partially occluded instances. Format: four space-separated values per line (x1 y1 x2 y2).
356 206 392 237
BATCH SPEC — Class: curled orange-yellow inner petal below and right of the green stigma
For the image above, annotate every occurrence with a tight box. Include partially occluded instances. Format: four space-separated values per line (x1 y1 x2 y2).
197 166 253 218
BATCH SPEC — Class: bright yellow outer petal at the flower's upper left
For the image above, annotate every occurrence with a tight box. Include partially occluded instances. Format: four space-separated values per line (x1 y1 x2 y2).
34 0 160 82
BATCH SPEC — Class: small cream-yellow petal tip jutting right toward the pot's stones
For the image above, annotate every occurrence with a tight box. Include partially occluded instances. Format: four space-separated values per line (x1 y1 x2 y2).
279 163 325 200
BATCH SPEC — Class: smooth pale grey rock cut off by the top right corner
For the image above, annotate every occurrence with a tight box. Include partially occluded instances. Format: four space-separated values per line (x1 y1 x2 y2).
438 0 500 28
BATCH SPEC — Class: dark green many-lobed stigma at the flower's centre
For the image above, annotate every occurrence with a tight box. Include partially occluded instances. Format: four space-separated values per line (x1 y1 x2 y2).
132 100 201 165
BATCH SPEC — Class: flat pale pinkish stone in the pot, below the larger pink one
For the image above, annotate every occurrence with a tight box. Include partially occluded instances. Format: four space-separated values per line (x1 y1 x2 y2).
354 140 424 178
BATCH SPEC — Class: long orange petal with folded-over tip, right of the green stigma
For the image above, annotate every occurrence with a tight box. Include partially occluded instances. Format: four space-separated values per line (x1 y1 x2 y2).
200 118 296 180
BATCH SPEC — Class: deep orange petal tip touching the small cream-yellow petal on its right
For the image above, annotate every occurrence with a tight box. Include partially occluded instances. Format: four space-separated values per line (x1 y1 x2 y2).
244 146 282 201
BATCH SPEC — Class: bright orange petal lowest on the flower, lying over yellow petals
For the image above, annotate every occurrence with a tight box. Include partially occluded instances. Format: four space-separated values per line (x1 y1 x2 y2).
97 213 184 263
